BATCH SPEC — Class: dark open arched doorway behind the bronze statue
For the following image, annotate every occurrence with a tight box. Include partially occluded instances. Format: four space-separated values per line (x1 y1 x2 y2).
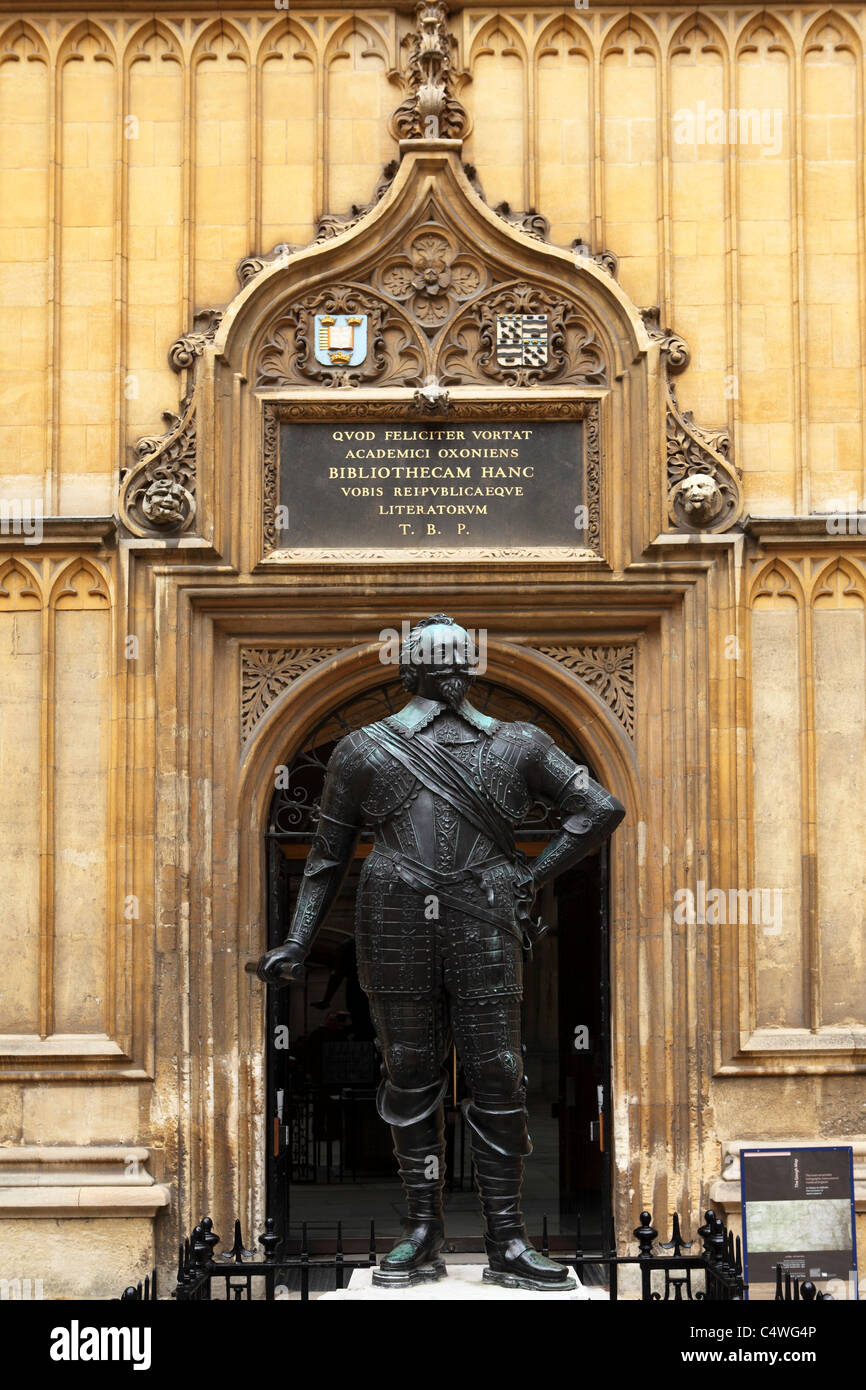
265 678 612 1251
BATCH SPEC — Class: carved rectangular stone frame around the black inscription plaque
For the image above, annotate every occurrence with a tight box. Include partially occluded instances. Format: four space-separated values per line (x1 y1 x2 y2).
261 391 602 564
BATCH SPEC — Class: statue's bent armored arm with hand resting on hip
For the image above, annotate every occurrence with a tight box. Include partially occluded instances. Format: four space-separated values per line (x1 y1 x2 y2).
530 731 626 888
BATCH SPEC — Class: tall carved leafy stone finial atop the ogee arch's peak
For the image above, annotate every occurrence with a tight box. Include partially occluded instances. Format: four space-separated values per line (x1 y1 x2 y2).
391 0 467 140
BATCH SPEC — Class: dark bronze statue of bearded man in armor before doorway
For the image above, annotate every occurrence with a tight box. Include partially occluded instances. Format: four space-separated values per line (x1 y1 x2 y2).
257 613 626 1290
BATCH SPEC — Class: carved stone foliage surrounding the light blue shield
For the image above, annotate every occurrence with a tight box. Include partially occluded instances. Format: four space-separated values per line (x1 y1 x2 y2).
254 284 425 386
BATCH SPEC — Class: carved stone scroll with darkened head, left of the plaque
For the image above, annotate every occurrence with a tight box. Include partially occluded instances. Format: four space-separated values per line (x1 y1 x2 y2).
120 393 196 535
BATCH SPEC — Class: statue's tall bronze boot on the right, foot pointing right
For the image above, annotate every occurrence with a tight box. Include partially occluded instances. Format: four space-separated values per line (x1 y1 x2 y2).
464 1101 577 1293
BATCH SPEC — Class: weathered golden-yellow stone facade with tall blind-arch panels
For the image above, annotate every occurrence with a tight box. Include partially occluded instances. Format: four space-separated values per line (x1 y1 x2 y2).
0 0 866 1297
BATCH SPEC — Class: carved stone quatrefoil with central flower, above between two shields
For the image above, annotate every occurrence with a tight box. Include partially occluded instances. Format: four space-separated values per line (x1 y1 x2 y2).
375 220 491 335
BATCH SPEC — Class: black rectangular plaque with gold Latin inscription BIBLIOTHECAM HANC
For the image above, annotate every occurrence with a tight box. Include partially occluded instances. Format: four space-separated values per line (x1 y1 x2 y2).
277 420 588 549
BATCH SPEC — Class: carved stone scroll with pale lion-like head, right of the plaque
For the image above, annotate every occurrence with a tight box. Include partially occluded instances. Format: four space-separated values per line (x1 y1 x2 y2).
642 307 742 531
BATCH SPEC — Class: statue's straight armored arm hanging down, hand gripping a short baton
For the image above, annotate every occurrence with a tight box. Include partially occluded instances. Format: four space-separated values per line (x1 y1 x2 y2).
259 734 366 981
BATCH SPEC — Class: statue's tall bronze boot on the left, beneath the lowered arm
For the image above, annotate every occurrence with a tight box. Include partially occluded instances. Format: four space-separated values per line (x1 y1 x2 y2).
373 1088 448 1289
